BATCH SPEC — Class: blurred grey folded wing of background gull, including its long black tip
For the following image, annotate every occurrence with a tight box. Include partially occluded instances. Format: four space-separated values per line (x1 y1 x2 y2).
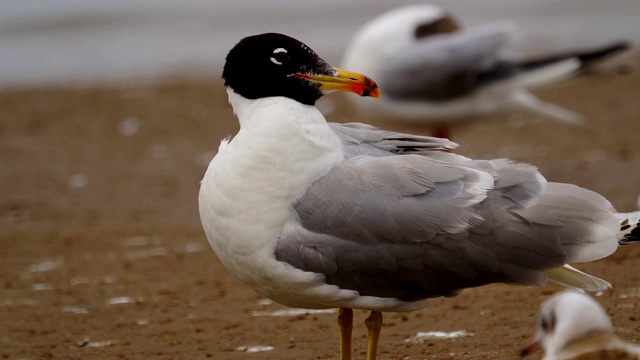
379 25 629 102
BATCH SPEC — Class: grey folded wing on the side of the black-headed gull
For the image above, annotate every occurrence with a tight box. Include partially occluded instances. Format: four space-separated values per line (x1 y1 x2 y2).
275 155 580 301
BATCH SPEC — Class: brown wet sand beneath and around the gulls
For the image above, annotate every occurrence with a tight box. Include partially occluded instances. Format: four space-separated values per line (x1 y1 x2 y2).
0 67 640 359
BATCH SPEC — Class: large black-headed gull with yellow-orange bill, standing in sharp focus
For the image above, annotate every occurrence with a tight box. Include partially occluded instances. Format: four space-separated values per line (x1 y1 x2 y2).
199 33 640 360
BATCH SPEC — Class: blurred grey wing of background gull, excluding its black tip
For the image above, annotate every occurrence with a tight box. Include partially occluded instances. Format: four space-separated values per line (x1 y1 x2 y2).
378 25 508 101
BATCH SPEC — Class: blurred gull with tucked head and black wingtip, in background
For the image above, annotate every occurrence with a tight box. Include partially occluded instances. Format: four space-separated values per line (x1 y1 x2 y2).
342 4 628 138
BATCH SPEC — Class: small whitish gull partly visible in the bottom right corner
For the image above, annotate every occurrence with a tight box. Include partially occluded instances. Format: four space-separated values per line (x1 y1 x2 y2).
521 291 640 360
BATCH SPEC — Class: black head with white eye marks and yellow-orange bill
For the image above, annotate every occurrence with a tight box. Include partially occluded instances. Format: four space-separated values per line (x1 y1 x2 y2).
222 33 379 105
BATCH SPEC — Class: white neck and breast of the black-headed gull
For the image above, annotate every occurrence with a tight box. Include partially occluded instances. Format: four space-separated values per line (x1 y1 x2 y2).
199 91 350 306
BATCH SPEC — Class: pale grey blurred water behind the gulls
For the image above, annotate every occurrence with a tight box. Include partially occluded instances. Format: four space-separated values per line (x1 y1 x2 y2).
0 0 640 86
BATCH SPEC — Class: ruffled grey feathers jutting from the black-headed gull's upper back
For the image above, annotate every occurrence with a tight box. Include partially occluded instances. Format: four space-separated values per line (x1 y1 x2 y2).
329 123 458 158
